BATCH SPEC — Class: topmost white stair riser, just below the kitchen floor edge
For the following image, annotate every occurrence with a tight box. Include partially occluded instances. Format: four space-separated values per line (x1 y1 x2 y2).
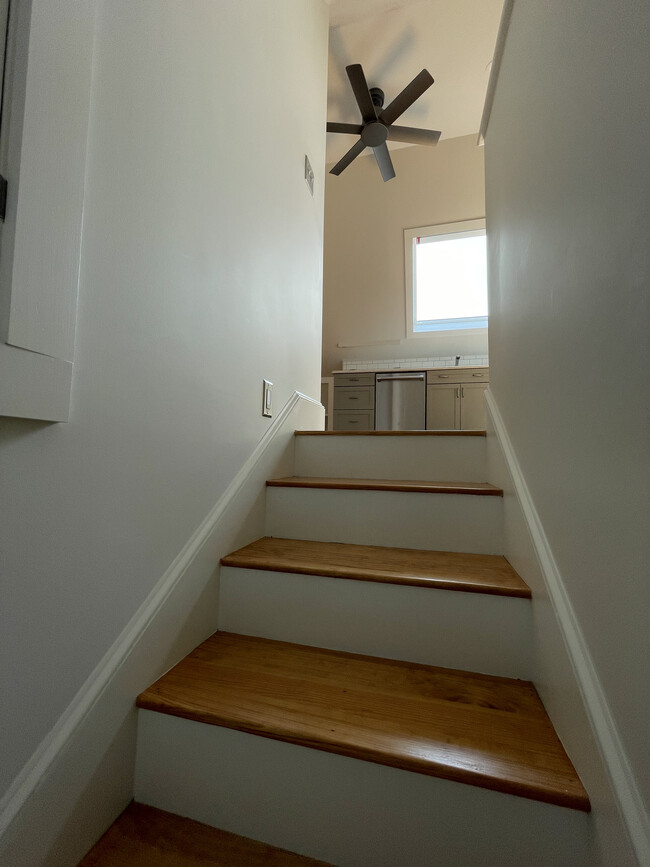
294 436 487 482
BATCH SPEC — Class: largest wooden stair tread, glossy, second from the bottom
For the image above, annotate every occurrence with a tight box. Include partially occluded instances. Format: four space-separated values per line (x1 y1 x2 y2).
137 632 590 810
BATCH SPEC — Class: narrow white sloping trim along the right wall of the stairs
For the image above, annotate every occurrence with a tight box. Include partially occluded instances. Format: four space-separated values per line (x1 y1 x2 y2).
485 389 650 864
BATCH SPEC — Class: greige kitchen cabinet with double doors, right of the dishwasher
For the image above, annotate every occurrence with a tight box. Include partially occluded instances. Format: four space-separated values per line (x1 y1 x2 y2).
427 368 490 430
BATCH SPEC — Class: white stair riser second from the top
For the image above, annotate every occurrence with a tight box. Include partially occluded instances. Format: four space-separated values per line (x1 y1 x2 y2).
266 487 503 554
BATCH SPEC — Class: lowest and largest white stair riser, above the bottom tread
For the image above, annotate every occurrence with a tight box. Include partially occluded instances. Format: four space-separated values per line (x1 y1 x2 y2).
135 711 591 867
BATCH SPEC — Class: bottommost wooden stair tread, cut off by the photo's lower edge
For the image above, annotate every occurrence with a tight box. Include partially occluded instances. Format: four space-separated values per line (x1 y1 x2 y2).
79 803 328 867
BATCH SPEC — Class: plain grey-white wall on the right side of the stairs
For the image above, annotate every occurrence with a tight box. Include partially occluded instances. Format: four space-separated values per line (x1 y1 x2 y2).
485 0 650 855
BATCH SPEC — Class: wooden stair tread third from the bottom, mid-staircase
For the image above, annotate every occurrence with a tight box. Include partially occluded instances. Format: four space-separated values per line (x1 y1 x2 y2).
221 536 531 598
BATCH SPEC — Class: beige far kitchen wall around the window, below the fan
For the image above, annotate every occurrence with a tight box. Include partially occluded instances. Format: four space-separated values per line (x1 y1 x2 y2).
323 136 487 376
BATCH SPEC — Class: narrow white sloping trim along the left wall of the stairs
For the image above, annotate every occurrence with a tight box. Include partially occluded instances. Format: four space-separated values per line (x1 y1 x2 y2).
0 391 321 837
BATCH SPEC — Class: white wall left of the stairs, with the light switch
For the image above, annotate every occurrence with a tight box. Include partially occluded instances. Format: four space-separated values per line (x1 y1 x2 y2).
0 0 327 860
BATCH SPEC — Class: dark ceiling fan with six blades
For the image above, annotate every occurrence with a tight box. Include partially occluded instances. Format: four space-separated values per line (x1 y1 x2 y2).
327 63 440 181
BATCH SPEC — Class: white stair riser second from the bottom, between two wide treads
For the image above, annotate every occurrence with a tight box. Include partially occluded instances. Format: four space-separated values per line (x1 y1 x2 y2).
219 567 532 680
